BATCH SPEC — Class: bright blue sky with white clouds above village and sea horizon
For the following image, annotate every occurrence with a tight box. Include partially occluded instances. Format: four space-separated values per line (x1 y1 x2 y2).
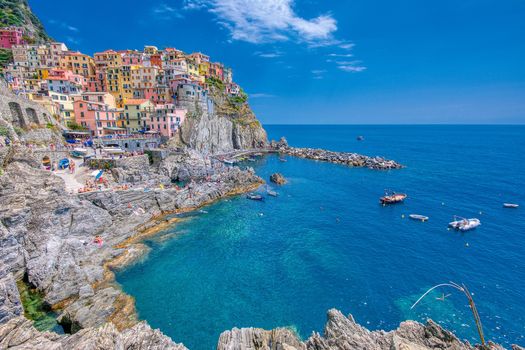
29 0 525 124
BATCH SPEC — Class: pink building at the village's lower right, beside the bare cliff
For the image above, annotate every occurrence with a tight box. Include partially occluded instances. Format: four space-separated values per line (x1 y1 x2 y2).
146 103 187 138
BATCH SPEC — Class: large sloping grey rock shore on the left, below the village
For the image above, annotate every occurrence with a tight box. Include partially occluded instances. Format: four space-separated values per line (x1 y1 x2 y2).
0 142 262 331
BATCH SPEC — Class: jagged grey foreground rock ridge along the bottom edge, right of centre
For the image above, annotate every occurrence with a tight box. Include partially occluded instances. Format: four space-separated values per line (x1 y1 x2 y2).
217 309 503 350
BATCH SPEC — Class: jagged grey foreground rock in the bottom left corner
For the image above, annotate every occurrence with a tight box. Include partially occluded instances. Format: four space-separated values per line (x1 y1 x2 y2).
0 317 186 350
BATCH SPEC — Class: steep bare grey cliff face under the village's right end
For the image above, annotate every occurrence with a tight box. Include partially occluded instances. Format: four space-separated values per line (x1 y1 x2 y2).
170 83 268 154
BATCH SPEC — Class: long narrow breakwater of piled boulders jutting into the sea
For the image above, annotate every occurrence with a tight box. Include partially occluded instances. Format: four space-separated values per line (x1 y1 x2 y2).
270 138 403 170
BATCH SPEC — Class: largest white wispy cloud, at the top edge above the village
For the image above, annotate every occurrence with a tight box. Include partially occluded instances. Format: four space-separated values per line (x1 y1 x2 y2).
184 0 337 46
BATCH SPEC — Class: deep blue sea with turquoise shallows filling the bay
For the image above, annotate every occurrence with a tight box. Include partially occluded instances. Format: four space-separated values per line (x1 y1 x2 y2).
117 126 525 350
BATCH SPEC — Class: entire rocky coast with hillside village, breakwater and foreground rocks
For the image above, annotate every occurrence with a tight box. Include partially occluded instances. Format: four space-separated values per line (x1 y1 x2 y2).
0 6 516 349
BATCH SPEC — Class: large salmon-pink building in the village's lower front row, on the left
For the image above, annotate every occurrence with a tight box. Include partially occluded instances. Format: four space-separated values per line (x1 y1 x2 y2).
73 92 126 137
